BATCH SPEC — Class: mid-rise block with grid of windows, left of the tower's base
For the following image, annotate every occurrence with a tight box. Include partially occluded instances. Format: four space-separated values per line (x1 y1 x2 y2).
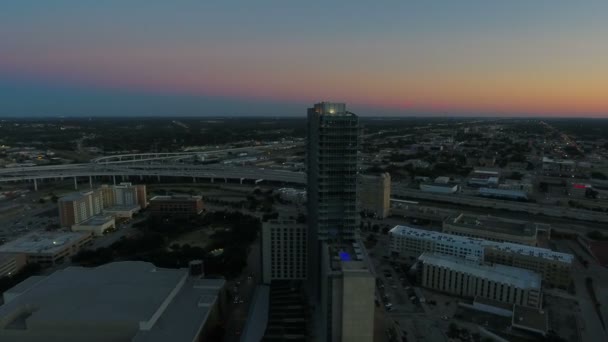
262 220 308 284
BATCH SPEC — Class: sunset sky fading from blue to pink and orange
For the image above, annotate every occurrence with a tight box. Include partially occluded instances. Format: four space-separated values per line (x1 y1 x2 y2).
0 0 608 117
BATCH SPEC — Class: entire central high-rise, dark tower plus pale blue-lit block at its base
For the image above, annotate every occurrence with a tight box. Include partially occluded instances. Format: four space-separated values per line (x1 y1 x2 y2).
307 102 375 342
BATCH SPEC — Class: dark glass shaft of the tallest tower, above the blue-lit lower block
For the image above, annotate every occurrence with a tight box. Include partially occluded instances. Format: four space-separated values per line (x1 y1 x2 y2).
307 102 359 241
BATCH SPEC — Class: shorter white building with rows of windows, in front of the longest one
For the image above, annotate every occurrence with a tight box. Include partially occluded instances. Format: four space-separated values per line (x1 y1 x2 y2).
418 253 542 308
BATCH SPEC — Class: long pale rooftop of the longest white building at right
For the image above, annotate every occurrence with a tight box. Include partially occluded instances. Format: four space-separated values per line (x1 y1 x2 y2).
389 226 574 264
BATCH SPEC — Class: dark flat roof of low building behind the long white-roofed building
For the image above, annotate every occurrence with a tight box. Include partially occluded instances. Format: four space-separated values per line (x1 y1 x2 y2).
446 214 537 236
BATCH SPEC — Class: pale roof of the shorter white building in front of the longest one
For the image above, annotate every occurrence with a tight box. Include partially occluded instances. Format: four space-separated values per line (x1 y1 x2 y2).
418 253 541 290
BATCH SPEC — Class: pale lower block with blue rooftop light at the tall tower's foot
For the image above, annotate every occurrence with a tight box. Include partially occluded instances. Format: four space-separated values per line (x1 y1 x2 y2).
320 242 376 342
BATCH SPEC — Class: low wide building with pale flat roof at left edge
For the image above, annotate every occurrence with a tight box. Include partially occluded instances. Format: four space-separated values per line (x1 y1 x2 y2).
0 232 92 267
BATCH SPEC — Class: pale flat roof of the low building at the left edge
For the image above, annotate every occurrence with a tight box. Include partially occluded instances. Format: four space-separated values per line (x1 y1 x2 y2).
0 232 89 254
